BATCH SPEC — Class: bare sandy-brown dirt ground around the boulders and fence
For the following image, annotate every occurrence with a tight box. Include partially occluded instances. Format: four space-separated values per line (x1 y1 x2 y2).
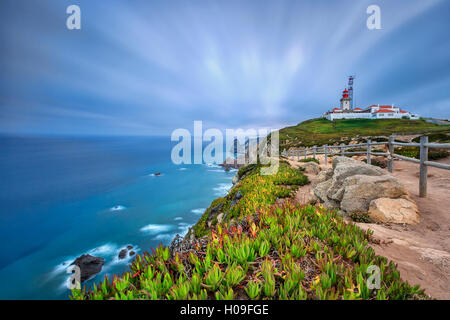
290 157 450 299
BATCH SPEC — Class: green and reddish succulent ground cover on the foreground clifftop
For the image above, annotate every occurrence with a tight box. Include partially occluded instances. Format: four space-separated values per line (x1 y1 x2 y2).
71 164 426 300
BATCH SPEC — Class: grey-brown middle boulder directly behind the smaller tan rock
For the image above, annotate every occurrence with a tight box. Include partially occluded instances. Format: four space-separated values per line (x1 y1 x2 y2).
340 175 408 213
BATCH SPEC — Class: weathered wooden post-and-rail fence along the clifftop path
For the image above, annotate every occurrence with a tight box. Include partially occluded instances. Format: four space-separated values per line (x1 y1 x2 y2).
282 136 450 198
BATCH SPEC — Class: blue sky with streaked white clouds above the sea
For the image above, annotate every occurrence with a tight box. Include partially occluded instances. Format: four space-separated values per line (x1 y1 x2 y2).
0 0 450 135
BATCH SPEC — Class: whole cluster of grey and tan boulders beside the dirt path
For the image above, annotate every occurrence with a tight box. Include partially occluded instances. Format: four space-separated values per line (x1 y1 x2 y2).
314 157 420 223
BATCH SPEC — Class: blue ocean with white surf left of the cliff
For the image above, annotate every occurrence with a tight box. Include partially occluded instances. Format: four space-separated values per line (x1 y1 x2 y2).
0 136 235 299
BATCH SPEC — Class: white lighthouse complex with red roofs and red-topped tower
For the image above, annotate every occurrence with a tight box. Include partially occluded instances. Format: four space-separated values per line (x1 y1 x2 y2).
323 89 420 120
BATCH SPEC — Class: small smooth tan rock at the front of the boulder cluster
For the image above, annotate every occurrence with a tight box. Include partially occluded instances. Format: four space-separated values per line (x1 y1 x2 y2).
368 198 420 224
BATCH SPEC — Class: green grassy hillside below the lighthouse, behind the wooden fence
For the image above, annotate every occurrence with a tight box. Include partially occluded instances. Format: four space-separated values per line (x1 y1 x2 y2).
280 118 450 150
